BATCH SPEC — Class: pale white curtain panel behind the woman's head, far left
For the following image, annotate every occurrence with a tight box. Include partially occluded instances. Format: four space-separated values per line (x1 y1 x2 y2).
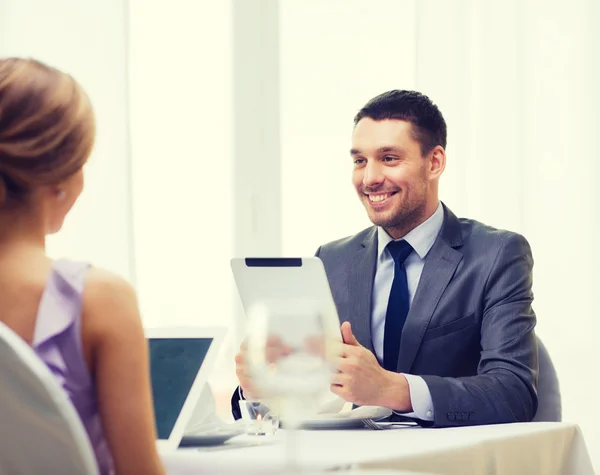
0 0 132 279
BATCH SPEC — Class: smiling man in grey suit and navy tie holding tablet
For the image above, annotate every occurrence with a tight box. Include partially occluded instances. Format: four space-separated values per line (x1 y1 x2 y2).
232 90 538 427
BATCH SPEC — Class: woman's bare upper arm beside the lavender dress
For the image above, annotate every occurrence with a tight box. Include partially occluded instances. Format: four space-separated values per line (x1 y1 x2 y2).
82 268 165 475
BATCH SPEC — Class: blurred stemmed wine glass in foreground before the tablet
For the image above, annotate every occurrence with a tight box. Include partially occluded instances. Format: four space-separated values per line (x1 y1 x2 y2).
247 300 339 474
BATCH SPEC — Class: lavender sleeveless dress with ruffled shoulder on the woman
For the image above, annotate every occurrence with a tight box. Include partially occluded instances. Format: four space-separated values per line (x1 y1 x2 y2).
33 260 114 475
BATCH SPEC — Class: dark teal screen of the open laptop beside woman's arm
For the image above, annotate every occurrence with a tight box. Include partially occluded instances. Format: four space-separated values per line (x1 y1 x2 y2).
148 338 213 440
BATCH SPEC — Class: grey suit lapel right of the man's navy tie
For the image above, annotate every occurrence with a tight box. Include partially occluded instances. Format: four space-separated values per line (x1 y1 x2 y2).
398 206 463 373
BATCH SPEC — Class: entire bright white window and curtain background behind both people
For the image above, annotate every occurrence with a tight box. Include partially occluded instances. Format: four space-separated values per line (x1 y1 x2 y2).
0 0 600 468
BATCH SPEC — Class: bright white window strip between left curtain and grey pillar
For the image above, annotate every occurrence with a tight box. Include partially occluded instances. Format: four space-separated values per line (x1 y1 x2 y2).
129 0 235 390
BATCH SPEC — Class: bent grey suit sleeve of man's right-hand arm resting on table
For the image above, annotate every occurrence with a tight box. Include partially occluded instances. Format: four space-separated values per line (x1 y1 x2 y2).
422 234 538 427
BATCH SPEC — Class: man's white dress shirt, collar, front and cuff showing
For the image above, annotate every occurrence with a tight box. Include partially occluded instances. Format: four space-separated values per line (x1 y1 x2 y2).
371 203 444 421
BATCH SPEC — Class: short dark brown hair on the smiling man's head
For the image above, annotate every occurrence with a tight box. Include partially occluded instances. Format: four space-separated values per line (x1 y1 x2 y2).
354 89 446 155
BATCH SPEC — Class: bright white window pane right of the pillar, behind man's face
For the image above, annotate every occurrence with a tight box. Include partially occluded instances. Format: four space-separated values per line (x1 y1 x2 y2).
280 0 415 255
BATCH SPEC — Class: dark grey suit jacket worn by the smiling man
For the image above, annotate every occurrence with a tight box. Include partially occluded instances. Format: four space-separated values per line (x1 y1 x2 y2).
317 206 538 427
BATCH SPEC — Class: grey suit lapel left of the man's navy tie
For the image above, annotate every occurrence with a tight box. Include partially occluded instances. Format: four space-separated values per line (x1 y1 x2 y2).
348 227 377 351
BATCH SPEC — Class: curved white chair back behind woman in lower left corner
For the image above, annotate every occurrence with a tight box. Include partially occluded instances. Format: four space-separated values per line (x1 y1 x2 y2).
0 323 98 475
